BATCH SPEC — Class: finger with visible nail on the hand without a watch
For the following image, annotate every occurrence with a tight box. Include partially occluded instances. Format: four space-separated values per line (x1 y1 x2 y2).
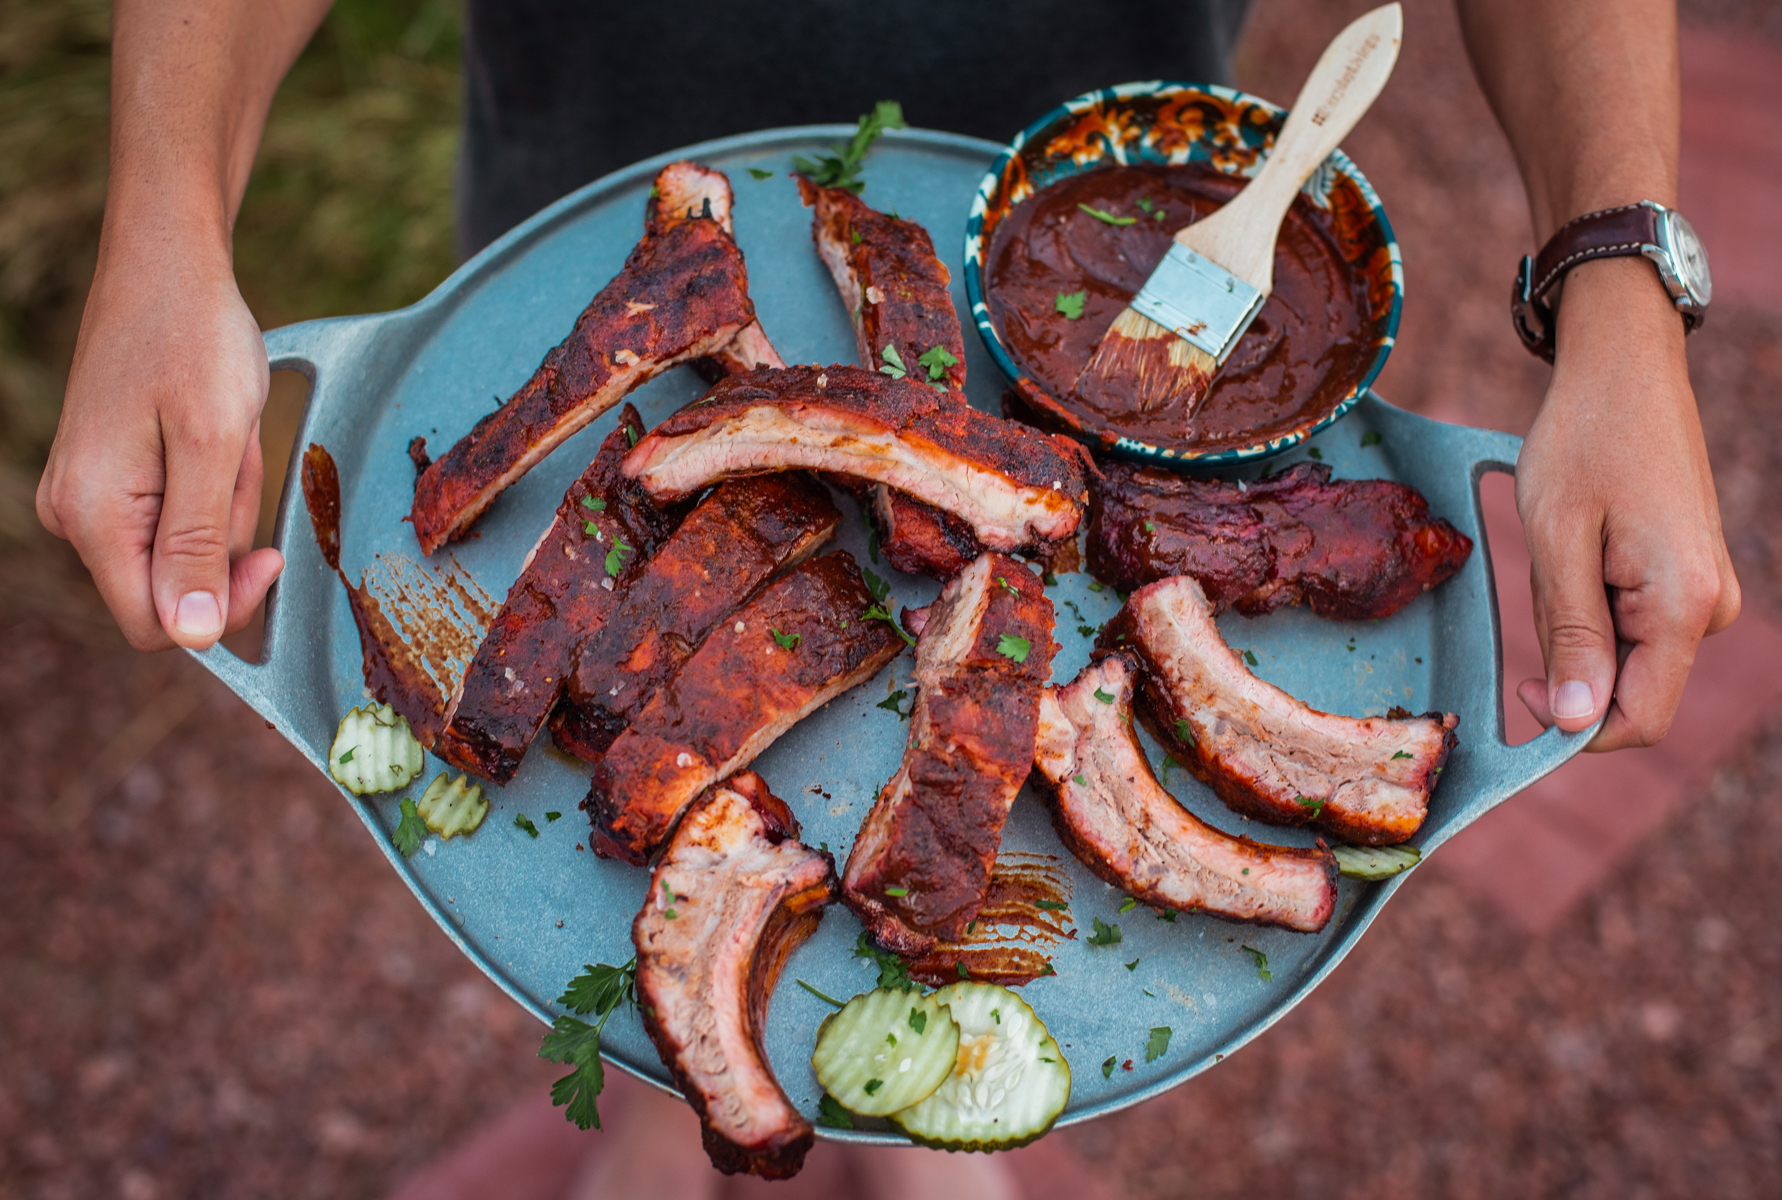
150 417 246 649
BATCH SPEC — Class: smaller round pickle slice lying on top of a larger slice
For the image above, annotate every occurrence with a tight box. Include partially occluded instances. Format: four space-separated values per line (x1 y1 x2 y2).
811 988 959 1116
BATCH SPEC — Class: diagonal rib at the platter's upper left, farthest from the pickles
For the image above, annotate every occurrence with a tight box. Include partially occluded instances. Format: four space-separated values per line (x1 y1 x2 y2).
410 164 764 555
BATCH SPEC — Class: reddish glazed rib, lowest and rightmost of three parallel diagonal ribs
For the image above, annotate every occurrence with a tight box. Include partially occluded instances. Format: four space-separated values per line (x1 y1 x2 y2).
581 551 903 863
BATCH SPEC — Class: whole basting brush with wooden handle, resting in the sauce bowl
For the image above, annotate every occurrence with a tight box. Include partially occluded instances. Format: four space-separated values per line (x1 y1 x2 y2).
1076 4 1404 415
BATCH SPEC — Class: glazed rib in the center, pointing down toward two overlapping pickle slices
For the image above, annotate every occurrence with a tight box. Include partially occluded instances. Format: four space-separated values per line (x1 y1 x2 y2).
843 555 1057 954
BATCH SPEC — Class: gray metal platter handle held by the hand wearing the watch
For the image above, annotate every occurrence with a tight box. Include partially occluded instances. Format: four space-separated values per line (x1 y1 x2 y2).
1422 426 1607 852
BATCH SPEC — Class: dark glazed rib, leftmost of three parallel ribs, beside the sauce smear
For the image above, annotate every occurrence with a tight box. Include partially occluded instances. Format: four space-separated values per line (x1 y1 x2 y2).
433 405 677 783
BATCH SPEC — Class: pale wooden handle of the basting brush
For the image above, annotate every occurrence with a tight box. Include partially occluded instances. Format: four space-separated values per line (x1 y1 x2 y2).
1176 4 1404 294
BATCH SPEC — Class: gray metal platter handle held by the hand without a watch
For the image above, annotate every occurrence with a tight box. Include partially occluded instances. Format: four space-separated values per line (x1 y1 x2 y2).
187 314 381 734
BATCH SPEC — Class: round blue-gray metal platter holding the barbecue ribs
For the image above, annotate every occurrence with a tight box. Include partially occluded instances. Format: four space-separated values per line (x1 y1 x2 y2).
198 125 1586 1145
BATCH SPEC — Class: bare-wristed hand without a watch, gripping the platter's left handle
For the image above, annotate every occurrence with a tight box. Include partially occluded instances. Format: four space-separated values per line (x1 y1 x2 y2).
37 230 283 649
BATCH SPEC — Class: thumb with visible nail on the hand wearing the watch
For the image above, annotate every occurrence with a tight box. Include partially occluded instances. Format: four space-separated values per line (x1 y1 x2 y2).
1524 519 1616 733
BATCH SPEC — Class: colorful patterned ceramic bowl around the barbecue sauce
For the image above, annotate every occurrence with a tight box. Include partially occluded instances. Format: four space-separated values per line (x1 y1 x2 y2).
964 80 1404 467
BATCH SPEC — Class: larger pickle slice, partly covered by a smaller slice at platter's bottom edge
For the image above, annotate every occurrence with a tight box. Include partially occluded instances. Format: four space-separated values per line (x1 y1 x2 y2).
891 982 1071 1150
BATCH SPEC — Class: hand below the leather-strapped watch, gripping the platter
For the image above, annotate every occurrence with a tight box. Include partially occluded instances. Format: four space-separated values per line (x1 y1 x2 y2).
1516 259 1739 751
